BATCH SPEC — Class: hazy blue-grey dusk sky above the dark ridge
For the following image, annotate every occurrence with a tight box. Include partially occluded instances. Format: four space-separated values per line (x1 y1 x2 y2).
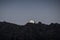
0 0 60 24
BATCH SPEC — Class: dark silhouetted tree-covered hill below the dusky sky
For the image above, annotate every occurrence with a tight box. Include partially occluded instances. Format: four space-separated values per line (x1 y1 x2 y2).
0 22 60 40
